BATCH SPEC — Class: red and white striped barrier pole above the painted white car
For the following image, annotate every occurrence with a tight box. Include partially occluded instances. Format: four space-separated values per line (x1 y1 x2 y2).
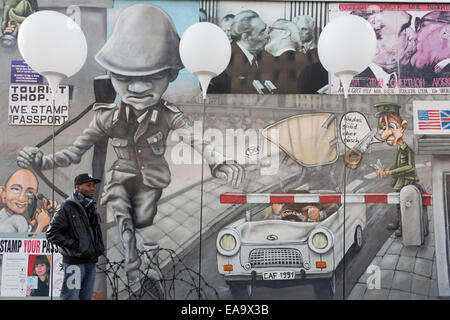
220 192 431 206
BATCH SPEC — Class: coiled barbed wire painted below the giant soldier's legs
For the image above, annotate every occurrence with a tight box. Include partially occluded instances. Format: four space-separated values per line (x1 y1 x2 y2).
97 248 219 300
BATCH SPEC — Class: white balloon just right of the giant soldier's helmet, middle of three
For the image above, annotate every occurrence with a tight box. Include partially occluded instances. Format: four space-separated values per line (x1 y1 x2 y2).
180 22 231 99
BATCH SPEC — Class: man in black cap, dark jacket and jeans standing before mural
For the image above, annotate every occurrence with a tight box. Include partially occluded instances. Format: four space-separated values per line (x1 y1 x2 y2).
46 173 105 300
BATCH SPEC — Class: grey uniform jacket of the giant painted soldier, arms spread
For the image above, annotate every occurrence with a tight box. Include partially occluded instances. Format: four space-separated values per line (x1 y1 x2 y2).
42 100 225 190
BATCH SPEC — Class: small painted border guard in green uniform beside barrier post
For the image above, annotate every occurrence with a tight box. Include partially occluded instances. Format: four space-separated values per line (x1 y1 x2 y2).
374 102 428 237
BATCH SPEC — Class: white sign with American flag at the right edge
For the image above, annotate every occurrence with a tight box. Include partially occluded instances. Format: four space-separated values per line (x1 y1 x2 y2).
413 101 450 134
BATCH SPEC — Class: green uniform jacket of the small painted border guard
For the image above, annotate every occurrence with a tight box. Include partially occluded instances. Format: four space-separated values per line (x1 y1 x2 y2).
390 143 419 192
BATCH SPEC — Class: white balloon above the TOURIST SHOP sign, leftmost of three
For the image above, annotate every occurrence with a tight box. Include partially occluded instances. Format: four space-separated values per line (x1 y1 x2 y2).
17 10 87 97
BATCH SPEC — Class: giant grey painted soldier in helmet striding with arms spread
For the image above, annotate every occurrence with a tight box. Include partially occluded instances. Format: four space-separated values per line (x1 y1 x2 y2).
17 4 244 281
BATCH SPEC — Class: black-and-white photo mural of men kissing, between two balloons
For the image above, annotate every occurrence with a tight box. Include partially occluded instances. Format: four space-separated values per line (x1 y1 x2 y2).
201 1 328 94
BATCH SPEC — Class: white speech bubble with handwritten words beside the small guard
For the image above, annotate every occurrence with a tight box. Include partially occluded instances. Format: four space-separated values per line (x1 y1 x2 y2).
339 111 383 150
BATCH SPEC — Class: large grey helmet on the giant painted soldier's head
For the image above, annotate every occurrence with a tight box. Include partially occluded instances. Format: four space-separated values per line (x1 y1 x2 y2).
95 4 184 76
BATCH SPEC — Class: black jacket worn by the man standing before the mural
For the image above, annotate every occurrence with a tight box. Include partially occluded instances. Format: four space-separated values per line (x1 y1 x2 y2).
46 192 105 264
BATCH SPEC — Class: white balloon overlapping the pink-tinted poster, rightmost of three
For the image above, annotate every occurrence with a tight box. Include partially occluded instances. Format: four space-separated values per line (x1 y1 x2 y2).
317 14 377 98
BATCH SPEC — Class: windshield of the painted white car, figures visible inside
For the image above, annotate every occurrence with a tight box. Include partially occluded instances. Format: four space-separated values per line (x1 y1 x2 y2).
251 203 340 223
